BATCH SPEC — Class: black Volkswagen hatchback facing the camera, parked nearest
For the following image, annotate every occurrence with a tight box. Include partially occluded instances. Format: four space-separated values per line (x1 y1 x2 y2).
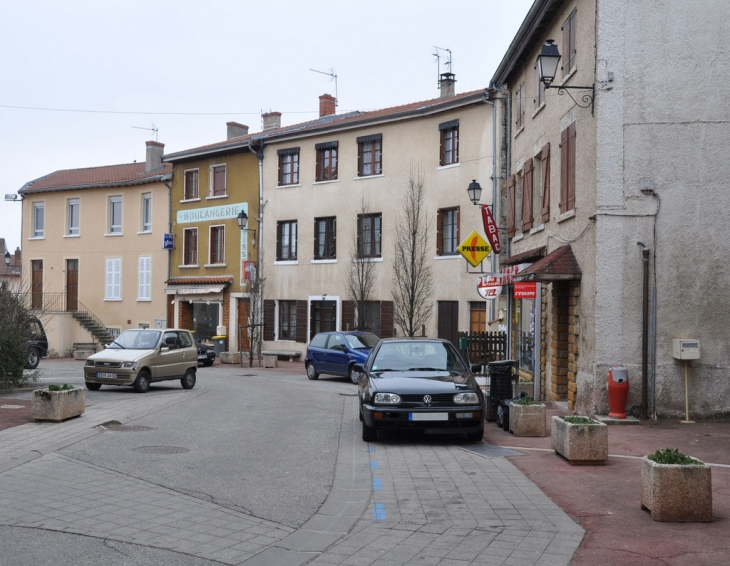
355 338 485 442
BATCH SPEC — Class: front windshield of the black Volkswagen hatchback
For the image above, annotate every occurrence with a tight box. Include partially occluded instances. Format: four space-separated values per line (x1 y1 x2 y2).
371 341 466 372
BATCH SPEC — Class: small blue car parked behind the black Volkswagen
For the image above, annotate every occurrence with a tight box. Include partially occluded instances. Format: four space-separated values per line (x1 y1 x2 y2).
304 331 379 383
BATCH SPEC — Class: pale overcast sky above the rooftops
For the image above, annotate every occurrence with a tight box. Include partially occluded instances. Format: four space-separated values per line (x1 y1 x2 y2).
0 0 532 252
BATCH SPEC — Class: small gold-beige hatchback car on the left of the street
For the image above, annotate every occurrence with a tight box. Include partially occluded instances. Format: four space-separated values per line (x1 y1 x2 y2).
84 328 198 393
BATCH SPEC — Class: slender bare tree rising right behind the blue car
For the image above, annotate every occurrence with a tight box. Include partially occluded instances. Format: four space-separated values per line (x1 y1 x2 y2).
346 197 380 330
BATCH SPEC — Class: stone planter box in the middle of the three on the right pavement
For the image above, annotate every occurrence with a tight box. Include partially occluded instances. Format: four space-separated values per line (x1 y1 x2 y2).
550 417 608 466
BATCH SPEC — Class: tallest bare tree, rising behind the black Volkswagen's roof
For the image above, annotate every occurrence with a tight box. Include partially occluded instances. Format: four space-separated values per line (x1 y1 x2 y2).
391 168 433 336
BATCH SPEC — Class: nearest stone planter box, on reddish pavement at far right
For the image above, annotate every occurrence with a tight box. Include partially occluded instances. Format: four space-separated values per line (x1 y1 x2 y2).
641 456 712 523
